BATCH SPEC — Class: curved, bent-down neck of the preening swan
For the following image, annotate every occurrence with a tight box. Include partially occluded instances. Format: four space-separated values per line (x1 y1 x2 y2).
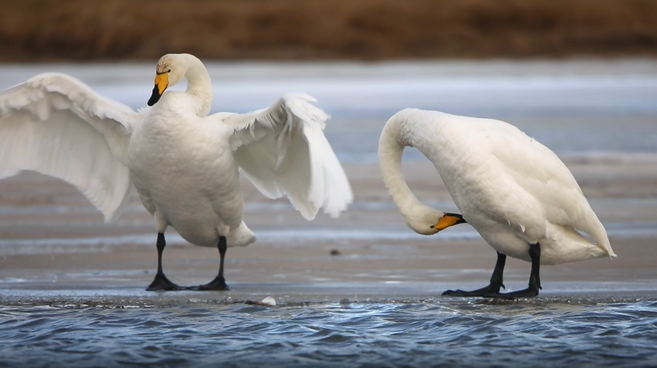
379 110 425 221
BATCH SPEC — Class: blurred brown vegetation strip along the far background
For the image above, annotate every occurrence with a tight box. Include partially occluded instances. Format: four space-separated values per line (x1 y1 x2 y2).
0 0 657 61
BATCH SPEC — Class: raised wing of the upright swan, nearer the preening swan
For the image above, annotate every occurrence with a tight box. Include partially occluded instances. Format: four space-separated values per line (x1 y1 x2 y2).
223 94 353 220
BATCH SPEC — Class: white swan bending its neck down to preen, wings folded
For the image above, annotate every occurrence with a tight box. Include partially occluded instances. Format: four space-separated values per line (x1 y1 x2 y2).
378 109 616 298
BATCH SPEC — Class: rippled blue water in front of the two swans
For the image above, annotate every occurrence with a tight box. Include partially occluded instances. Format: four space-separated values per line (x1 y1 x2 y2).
0 299 657 367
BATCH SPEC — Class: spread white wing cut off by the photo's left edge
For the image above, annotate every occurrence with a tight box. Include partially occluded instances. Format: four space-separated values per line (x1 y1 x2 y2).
0 73 139 221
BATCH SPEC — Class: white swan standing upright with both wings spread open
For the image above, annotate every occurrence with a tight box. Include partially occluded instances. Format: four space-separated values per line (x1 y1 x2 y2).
0 54 353 290
